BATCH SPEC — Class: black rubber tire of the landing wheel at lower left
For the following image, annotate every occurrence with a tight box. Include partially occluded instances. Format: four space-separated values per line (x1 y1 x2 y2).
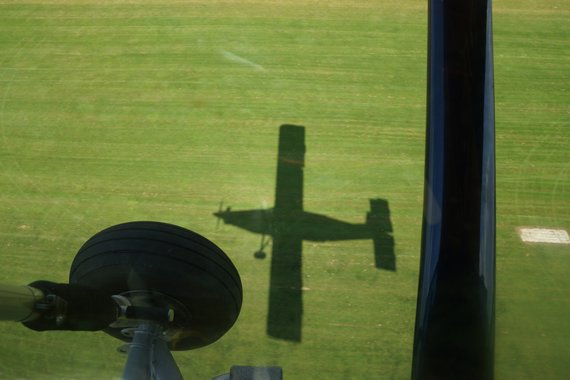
69 222 242 350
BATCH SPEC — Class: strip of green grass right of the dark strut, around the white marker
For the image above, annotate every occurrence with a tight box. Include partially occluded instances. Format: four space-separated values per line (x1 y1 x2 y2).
495 2 570 379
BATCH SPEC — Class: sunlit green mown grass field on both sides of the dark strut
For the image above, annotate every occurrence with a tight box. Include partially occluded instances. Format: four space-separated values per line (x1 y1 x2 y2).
0 0 570 379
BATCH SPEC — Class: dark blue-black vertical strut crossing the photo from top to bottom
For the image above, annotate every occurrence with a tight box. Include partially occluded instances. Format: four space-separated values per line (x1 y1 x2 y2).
412 0 495 380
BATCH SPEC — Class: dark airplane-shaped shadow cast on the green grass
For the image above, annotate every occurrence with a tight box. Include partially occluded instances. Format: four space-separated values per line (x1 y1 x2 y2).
214 125 396 342
